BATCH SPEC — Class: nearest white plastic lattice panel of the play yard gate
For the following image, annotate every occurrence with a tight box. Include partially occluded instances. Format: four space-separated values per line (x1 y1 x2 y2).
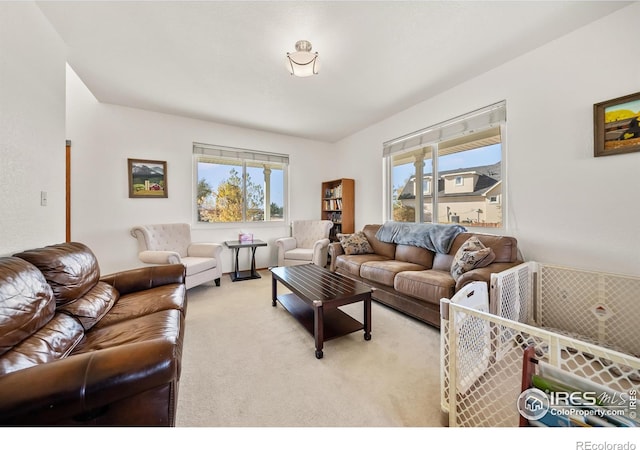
441 304 640 427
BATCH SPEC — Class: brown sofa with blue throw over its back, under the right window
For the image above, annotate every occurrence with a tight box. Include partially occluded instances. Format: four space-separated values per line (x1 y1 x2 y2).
329 225 522 328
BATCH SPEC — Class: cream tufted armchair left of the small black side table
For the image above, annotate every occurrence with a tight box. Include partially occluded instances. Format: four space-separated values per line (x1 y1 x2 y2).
131 223 222 289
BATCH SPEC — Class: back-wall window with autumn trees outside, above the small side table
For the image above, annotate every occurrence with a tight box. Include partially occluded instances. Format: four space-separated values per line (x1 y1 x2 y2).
193 143 289 223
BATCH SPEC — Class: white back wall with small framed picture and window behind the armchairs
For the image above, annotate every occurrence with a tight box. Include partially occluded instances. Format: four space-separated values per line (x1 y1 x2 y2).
67 68 332 273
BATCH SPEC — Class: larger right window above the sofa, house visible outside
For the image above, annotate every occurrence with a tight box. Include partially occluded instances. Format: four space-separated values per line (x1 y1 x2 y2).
383 101 506 228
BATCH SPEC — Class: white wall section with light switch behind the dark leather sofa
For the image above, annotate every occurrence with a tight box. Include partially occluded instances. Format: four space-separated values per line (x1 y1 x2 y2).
0 2 66 255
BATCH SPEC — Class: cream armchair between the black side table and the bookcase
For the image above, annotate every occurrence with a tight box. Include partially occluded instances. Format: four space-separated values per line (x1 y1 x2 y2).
276 220 333 267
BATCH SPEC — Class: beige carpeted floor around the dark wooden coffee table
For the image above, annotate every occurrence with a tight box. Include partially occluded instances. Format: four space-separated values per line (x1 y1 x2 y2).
177 270 442 427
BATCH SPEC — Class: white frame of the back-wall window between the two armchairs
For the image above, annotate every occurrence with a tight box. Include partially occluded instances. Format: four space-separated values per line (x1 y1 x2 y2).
191 142 290 228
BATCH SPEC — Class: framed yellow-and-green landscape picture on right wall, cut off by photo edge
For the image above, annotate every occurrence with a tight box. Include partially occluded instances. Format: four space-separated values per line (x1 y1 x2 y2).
593 92 640 156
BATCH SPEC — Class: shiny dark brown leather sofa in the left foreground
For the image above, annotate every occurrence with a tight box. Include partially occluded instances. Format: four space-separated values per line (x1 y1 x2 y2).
0 243 187 426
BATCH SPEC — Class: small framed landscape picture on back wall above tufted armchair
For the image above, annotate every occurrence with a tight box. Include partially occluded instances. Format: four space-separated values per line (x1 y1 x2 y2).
127 159 168 198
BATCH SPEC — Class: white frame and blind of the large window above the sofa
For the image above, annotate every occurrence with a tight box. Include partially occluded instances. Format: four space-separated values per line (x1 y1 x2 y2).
383 100 508 231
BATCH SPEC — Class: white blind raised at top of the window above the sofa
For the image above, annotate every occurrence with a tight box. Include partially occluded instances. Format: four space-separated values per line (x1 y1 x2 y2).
382 101 507 157
